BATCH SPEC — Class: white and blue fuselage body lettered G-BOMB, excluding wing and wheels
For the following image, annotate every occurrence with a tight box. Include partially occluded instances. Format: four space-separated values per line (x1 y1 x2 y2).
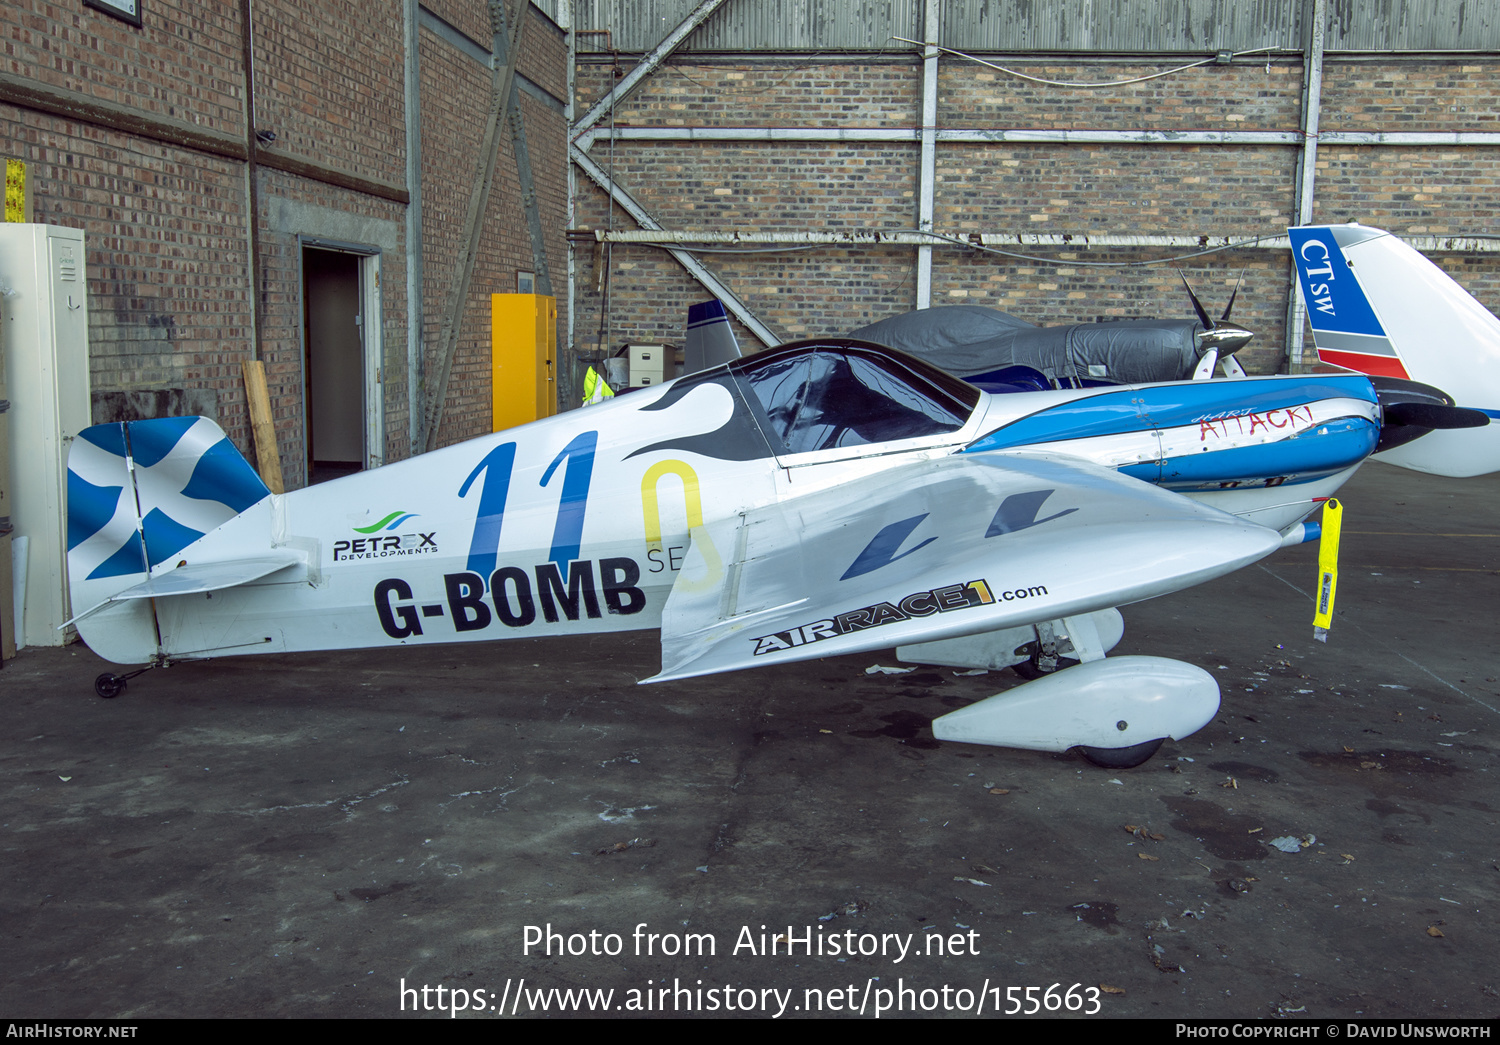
75 348 1379 663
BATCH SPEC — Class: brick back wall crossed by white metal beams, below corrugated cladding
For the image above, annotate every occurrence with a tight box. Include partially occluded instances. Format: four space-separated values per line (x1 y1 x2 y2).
576 55 1500 379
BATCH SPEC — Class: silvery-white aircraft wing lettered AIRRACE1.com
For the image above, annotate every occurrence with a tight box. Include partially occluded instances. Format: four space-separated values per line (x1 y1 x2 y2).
650 451 1281 682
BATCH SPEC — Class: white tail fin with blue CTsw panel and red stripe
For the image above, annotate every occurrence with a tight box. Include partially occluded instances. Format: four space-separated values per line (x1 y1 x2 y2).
1287 225 1500 477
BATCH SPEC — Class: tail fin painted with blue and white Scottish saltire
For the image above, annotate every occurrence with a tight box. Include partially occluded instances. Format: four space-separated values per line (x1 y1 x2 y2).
68 417 270 663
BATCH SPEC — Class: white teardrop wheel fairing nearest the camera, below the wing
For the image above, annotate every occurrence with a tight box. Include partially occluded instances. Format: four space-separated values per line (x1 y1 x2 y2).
933 657 1220 751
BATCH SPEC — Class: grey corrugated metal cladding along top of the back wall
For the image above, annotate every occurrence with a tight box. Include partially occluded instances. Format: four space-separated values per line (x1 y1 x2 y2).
567 0 1500 54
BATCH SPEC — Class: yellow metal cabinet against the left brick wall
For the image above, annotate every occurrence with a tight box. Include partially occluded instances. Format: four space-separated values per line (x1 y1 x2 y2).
489 294 558 432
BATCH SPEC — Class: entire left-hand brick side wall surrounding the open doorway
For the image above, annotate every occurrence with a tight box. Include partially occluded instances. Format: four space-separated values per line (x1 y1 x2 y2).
0 0 567 487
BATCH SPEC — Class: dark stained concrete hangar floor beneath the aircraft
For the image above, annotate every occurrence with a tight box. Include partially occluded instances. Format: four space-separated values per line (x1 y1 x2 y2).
0 465 1500 1018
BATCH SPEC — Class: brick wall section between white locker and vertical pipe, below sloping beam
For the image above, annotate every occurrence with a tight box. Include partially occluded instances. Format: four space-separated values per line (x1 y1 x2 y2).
0 105 251 434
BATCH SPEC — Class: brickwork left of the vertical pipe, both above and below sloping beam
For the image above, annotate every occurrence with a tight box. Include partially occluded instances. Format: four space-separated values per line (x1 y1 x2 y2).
0 0 251 447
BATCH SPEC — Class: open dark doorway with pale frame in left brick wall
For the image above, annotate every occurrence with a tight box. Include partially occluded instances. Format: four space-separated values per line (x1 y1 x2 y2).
302 240 383 486
